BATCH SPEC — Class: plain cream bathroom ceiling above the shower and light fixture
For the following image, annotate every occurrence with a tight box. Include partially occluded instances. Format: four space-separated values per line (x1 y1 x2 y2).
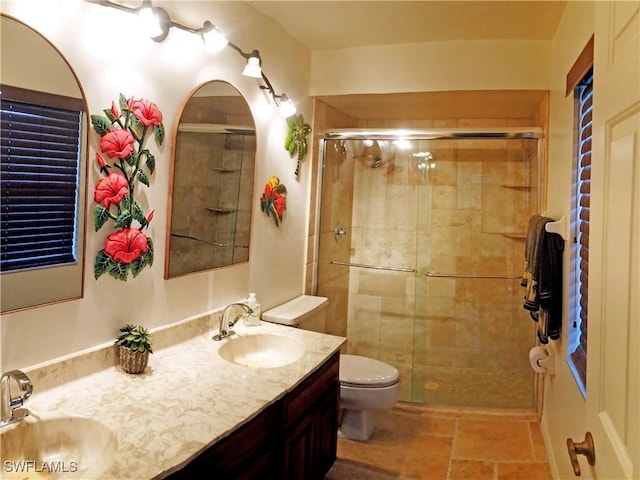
248 0 566 51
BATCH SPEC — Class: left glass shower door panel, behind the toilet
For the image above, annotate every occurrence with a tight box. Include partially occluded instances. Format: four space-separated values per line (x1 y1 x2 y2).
318 140 418 401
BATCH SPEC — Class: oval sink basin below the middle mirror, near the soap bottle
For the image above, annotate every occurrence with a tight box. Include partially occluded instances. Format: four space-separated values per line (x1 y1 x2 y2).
218 333 305 368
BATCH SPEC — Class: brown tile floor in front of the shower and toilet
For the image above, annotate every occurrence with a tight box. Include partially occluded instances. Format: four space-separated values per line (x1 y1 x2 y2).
325 403 552 480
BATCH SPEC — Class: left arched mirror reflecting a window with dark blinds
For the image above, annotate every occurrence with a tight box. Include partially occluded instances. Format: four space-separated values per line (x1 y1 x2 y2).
0 15 88 313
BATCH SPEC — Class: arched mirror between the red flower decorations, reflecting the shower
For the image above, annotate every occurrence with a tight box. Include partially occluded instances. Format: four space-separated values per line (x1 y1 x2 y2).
165 81 256 278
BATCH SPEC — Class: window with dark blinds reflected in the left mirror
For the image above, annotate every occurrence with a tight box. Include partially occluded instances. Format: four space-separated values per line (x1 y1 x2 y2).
0 86 82 272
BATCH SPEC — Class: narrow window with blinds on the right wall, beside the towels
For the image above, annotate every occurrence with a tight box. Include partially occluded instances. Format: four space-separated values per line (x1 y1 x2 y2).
570 67 593 392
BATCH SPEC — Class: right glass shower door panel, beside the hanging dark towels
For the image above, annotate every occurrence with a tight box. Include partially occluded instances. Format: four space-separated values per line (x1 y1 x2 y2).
412 139 538 408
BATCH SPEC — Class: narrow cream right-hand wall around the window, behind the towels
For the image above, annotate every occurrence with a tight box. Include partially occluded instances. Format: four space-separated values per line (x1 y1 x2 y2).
542 2 595 478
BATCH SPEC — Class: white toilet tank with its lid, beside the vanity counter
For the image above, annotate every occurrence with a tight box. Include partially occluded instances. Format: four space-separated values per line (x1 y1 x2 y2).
262 295 329 333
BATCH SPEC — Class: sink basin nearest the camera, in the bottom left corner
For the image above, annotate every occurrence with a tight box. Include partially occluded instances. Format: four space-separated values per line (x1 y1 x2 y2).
0 417 117 480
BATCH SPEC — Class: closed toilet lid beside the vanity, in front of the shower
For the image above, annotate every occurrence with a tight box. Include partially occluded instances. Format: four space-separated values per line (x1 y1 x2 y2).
340 354 400 387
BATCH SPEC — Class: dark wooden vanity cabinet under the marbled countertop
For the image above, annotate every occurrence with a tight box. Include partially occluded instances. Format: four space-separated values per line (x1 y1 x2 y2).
161 352 340 480
